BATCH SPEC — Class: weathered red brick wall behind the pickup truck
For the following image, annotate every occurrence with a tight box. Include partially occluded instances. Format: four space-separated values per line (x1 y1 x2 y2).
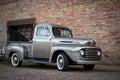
0 0 120 65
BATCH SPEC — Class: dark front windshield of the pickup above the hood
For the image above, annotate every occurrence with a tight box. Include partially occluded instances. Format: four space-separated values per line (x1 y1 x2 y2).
52 27 72 37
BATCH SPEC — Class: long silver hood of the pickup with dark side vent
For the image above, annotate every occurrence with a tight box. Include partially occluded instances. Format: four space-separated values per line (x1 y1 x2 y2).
52 38 95 46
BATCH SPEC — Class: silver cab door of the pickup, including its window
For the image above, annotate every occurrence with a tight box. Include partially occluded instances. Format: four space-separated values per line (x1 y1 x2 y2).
33 26 51 59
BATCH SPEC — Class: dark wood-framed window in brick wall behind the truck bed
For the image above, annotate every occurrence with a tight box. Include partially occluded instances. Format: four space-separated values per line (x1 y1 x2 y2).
7 18 36 41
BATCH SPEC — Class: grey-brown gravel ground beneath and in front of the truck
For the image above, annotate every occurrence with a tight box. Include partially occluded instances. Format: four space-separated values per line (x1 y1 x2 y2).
0 64 120 80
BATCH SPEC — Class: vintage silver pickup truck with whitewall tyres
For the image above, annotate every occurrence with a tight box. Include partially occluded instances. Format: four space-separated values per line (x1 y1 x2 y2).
0 24 102 71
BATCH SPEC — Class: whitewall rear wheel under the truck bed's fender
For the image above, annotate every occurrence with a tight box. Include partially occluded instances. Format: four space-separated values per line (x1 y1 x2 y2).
11 53 22 67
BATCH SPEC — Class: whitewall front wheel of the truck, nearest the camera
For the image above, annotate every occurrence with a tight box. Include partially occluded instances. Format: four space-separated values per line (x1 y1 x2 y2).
57 53 69 71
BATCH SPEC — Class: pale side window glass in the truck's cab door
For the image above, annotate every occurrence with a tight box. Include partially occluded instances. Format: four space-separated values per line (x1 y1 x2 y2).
36 27 50 37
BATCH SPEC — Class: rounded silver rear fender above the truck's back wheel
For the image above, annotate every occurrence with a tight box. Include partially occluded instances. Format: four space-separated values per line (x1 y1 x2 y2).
6 45 24 60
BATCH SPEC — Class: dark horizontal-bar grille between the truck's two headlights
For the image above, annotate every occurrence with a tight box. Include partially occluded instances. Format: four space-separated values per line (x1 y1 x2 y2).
84 49 98 60
